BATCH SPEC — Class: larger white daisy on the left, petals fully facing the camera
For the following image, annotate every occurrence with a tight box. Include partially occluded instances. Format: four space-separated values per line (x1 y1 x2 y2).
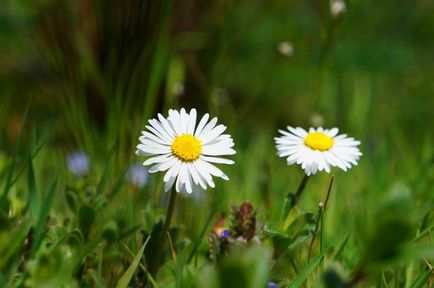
136 108 235 193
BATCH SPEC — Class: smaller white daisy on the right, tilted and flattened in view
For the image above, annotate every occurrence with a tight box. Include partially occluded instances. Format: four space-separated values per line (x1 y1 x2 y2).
274 126 362 176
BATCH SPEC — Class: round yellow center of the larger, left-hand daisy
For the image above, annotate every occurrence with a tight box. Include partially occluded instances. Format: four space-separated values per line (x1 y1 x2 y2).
172 134 202 162
